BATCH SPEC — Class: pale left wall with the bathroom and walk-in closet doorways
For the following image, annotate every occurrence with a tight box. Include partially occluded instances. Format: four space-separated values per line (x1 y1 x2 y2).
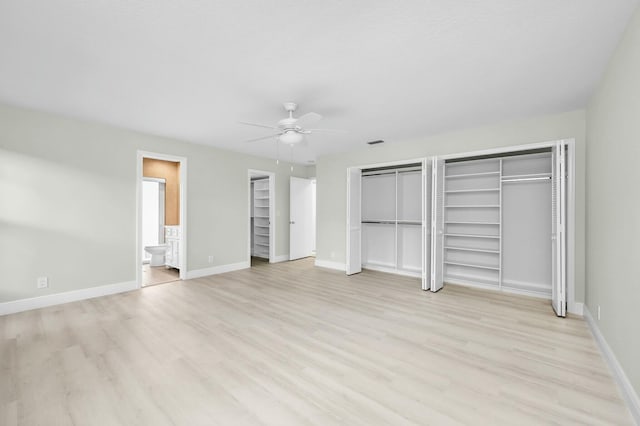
0 105 310 303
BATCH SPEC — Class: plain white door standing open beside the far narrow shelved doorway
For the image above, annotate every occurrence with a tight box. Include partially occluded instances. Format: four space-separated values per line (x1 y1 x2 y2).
289 176 314 260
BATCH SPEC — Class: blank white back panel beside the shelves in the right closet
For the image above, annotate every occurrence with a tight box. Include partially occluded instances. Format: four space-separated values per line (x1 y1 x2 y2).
502 180 552 297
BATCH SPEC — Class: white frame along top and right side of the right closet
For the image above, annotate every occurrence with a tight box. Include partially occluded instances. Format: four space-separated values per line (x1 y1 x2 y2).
437 139 584 315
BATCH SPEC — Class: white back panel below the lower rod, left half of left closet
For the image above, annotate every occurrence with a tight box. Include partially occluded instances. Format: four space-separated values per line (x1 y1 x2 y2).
362 223 396 268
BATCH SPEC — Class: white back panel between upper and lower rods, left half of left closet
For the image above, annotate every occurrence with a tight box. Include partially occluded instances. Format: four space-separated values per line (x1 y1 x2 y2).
362 173 396 220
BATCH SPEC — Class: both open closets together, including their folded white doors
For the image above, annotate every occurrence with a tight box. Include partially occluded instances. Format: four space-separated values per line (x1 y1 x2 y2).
345 139 581 316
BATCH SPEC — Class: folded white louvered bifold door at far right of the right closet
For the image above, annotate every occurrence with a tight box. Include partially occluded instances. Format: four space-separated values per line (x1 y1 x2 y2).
551 143 567 317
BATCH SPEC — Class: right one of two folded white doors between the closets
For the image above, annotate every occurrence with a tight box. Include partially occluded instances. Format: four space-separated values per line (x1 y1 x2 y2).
430 158 444 292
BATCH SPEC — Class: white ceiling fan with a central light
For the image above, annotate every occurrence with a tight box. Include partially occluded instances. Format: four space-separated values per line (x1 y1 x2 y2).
240 102 335 146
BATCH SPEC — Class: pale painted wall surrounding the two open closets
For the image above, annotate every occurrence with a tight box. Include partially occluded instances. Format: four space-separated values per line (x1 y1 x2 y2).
316 111 585 302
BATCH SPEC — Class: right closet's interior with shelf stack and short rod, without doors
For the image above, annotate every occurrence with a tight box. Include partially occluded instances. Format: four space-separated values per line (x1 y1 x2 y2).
442 152 551 296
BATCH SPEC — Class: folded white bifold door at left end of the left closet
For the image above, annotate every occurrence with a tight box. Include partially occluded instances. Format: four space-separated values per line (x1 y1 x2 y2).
346 167 362 275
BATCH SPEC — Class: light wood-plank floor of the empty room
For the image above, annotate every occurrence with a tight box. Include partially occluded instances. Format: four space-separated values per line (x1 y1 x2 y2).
0 259 631 426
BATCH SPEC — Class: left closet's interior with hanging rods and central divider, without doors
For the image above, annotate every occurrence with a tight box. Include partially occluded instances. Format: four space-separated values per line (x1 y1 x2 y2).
362 164 422 277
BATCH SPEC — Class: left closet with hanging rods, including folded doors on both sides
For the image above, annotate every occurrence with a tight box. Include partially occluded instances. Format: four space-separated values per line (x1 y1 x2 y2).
347 159 431 288
